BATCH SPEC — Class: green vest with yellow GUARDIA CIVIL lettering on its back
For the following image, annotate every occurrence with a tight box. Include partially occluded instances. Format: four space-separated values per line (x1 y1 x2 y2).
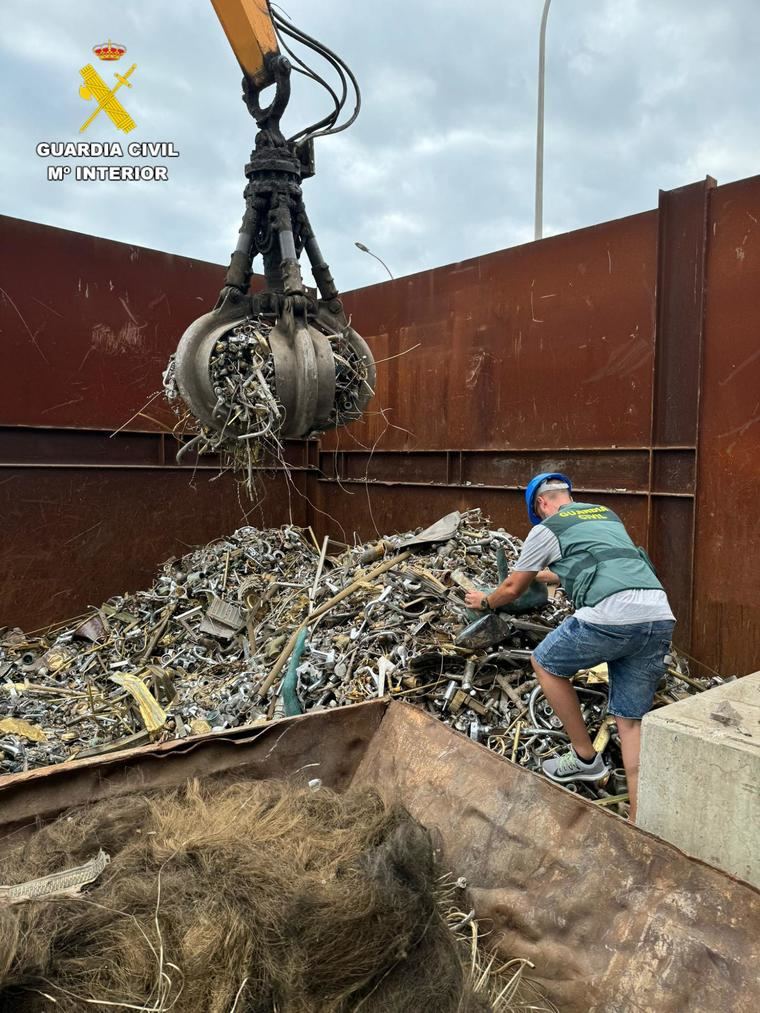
541 502 663 609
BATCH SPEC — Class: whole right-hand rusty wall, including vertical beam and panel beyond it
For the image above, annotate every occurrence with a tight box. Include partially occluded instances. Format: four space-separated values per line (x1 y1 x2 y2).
316 177 760 675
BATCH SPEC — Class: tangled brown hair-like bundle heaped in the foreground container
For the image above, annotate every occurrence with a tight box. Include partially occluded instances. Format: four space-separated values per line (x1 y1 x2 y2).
0 781 551 1013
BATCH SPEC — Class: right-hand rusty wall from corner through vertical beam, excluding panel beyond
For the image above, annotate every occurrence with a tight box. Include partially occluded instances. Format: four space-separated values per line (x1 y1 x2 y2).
317 201 701 647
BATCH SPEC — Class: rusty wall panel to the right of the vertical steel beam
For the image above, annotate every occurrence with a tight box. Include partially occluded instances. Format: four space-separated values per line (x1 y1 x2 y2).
692 176 760 675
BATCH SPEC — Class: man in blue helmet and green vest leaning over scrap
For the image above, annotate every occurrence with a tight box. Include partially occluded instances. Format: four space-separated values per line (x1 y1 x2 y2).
465 472 675 821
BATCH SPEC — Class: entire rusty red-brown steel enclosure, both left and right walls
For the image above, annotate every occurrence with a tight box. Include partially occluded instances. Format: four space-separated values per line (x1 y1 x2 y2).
0 177 760 674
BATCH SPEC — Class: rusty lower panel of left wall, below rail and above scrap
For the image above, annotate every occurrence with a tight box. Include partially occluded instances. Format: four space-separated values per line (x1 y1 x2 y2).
0 464 305 632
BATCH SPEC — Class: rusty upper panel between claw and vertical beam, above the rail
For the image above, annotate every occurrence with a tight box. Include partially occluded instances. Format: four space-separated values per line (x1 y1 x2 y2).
334 211 658 450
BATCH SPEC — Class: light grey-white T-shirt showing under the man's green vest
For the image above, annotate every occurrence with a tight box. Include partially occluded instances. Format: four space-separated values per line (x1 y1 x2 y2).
514 524 676 626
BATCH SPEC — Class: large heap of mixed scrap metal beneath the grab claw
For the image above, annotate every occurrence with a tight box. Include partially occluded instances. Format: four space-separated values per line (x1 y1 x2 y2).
0 510 711 811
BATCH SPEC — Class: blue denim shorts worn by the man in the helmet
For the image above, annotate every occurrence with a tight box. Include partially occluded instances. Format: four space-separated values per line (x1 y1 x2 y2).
533 616 676 720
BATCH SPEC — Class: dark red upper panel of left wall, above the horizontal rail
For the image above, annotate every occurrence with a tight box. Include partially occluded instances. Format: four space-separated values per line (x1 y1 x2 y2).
0 216 224 430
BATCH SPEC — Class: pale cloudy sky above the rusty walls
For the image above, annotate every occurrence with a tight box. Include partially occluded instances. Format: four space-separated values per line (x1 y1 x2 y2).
0 0 760 290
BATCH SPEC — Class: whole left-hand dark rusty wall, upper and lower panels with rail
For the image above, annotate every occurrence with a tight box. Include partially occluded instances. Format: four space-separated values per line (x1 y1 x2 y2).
0 217 306 630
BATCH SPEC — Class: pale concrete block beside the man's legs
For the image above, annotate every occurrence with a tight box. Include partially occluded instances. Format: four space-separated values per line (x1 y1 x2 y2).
636 672 760 887
